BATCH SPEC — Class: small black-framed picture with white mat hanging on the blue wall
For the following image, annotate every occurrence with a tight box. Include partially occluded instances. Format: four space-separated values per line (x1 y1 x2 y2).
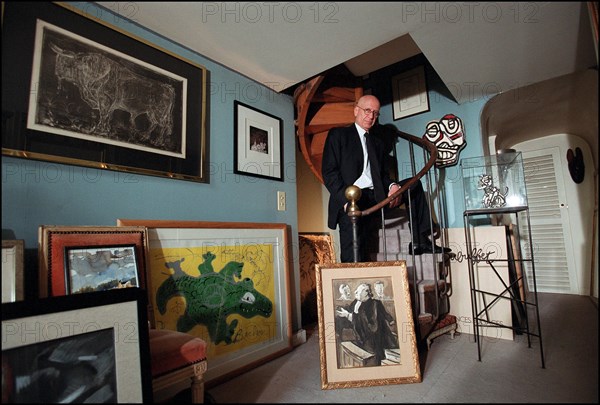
233 100 283 181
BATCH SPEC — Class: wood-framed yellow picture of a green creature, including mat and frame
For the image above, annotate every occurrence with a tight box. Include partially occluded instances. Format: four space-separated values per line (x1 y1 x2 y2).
117 219 292 385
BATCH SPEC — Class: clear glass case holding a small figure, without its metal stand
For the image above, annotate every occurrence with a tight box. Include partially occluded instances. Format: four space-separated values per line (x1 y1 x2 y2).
460 149 527 211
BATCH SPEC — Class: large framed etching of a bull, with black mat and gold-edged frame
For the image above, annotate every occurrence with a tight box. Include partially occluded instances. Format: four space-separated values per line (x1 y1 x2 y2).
2 2 208 182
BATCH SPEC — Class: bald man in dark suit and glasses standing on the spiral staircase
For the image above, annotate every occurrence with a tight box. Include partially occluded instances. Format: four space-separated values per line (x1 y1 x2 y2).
321 95 449 263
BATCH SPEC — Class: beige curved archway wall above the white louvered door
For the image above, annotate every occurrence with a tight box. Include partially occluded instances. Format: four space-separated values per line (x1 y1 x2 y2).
481 69 600 299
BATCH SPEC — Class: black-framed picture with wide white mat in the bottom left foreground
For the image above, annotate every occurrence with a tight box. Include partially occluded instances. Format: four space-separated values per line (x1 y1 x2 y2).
2 288 152 403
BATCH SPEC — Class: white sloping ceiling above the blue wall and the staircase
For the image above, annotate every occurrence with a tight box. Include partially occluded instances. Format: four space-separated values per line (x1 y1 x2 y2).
98 2 597 104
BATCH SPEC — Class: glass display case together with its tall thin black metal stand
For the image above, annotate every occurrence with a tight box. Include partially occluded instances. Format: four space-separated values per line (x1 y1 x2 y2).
460 149 545 368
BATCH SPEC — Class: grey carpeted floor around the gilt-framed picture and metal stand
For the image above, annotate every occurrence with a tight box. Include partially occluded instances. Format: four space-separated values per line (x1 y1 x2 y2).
206 293 598 403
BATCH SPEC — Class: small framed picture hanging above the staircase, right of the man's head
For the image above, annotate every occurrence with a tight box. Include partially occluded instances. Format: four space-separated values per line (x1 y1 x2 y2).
392 65 429 120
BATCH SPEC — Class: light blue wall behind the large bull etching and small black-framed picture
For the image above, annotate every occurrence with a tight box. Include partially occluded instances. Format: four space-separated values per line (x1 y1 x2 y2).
2 3 298 324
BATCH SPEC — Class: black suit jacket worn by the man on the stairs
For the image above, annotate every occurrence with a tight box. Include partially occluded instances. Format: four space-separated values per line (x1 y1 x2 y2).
321 124 392 229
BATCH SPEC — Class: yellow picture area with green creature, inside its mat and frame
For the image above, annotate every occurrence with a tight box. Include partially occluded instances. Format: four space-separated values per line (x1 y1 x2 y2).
149 244 277 358
